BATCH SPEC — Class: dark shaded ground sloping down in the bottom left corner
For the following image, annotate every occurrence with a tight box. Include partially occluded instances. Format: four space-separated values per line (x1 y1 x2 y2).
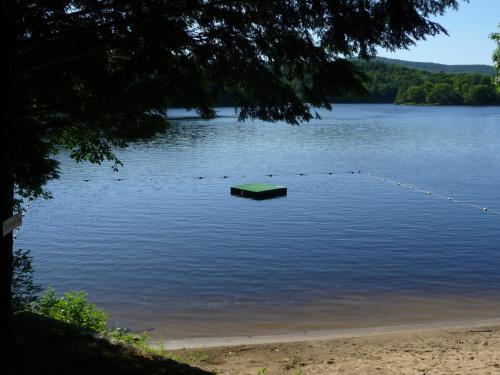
0 314 212 375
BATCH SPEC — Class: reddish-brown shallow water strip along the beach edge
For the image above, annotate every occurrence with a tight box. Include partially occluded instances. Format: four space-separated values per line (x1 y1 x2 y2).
120 294 500 348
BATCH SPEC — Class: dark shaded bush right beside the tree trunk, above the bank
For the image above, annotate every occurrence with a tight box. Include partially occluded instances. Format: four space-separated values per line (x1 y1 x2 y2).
12 249 41 313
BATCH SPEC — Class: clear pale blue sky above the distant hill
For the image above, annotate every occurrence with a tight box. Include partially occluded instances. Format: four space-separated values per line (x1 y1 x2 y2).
378 0 500 65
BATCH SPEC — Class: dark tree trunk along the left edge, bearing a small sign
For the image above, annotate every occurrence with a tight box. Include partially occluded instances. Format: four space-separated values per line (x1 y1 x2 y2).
0 0 15 343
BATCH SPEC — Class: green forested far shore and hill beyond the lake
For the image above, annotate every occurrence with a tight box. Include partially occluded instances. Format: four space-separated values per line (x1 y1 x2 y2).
332 59 500 105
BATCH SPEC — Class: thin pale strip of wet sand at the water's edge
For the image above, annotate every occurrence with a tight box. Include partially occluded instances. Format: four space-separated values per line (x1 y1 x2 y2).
156 318 500 350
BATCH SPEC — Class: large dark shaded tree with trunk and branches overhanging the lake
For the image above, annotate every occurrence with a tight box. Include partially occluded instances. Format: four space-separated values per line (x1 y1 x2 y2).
0 0 458 340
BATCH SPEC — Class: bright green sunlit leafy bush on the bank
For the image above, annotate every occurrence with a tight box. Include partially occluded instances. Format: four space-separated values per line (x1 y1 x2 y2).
37 288 107 332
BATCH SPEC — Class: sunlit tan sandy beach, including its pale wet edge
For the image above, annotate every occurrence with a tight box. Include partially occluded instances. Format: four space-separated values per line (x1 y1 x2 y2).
165 320 500 375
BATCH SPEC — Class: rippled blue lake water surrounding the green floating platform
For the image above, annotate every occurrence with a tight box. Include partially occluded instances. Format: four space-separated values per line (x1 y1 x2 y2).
16 105 500 338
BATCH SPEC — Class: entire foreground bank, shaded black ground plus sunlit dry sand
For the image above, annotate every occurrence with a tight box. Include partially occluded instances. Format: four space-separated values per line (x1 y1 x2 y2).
0 314 500 375
